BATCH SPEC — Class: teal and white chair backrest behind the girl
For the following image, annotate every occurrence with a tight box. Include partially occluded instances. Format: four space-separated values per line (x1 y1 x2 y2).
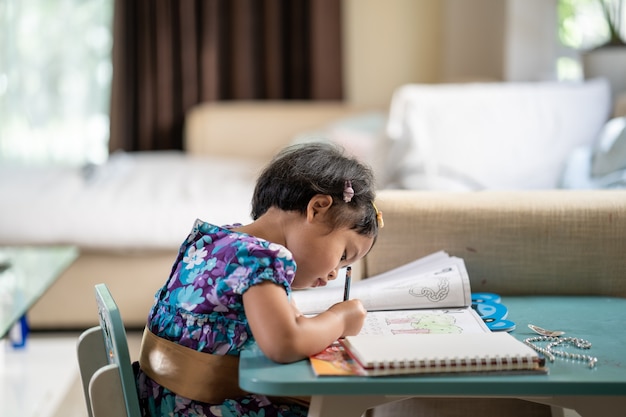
77 284 141 417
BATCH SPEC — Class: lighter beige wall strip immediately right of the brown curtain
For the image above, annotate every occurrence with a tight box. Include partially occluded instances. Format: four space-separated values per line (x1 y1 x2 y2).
343 0 442 108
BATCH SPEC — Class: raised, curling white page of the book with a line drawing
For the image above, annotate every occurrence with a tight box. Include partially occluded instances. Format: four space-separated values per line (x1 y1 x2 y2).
292 252 471 314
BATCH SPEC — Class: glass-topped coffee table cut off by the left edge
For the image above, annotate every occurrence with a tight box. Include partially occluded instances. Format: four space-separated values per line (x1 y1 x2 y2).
0 246 78 345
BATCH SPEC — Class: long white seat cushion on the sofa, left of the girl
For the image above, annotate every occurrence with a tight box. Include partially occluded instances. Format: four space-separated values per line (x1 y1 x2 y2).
0 152 261 250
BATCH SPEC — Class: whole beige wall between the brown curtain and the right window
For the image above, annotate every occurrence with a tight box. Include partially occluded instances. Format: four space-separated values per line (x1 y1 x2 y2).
343 0 557 108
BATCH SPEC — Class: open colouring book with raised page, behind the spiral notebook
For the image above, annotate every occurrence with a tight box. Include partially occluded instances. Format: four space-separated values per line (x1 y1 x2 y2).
292 251 489 335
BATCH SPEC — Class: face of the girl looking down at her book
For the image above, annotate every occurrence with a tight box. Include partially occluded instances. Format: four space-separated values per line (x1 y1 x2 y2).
287 218 374 288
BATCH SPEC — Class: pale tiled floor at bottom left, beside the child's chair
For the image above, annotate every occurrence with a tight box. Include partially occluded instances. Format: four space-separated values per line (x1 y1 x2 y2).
0 332 141 417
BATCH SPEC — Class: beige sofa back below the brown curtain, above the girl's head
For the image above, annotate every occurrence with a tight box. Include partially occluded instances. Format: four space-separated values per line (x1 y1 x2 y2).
184 101 358 162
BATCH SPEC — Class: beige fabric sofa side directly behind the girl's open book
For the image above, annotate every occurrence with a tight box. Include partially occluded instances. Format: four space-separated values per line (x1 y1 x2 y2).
364 190 626 297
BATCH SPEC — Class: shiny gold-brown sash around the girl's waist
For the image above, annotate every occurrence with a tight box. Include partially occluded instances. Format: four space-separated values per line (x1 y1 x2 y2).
139 328 247 404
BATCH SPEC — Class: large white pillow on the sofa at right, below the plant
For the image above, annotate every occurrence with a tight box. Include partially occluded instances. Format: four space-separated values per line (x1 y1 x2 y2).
387 79 611 190
